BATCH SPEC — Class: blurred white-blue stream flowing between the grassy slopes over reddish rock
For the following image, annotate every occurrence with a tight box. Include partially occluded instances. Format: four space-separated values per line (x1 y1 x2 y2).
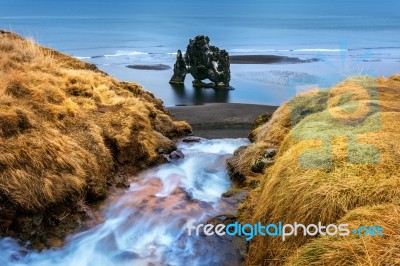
0 139 248 266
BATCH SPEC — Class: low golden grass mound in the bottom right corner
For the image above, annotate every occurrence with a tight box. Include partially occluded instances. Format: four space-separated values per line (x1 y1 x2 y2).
286 204 400 266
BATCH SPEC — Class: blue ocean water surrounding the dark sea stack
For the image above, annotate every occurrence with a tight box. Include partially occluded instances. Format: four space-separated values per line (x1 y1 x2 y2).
0 0 400 106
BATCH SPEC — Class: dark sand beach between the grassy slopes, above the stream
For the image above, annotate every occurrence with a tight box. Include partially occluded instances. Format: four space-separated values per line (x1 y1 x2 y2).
167 103 278 139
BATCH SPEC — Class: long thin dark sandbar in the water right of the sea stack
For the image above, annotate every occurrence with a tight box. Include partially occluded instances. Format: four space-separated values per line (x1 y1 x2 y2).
229 55 319 64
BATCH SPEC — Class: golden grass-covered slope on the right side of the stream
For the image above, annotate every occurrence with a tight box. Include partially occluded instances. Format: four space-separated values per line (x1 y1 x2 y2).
231 75 400 265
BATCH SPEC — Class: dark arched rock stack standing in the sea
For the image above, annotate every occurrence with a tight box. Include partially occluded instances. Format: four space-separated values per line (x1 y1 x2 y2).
170 35 231 88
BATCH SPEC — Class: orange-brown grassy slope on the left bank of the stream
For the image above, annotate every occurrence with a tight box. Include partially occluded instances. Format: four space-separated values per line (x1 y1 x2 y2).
0 31 191 211
